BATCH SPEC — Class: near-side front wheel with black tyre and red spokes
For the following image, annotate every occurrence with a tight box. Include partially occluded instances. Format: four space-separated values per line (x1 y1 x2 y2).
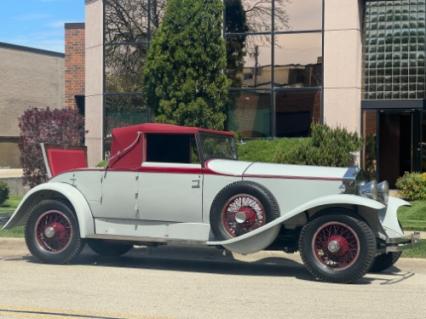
299 215 376 283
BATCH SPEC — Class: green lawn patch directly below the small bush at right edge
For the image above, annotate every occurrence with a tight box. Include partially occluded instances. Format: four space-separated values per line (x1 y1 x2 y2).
398 200 426 231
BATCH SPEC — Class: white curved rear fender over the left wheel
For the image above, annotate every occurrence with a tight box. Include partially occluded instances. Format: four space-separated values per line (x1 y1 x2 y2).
3 182 95 238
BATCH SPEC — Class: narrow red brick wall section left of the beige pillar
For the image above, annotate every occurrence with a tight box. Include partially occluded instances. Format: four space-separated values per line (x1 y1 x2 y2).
65 23 85 109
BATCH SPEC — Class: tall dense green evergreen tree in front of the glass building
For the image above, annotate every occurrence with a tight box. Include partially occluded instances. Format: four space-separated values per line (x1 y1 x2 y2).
144 0 229 129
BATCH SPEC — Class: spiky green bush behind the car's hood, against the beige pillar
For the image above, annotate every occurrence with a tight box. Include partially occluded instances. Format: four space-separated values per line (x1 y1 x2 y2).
275 124 362 167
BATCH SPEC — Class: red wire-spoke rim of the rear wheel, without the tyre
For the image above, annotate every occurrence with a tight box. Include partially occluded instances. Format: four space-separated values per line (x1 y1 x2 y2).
34 210 73 253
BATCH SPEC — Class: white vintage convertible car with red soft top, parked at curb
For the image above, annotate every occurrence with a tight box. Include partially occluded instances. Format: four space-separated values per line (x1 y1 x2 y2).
4 124 418 282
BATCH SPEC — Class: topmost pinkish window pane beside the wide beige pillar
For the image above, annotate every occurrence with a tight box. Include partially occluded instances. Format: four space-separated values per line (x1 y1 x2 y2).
275 0 322 31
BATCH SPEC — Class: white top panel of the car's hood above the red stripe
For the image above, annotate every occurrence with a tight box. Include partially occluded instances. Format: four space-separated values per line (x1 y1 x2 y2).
207 160 358 180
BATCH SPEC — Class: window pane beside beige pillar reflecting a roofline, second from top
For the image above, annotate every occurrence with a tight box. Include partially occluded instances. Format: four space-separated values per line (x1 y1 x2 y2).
274 33 322 87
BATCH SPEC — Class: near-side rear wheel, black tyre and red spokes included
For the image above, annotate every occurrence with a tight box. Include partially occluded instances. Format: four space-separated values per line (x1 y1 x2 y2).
25 200 84 264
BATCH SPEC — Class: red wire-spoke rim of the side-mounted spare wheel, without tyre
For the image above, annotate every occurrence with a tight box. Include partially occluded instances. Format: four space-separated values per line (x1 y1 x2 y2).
222 194 266 237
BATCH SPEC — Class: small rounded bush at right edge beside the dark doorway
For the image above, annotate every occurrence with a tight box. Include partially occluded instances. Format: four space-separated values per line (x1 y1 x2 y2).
396 172 426 201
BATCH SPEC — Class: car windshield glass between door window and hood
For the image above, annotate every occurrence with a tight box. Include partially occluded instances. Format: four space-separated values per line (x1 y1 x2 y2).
200 133 237 161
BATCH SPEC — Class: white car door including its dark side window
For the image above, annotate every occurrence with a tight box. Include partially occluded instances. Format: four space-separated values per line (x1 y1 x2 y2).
138 134 203 223
